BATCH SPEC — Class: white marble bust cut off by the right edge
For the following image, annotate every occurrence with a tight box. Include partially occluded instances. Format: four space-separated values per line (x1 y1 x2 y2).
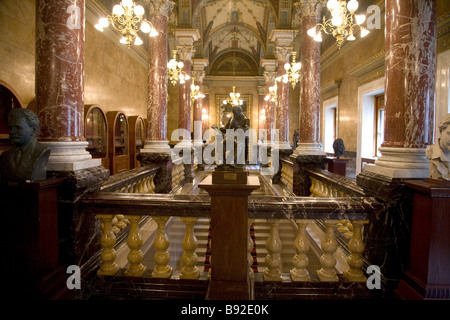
426 113 450 181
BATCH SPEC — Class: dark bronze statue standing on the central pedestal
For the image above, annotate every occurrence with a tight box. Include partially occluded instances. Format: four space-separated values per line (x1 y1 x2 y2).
211 106 250 167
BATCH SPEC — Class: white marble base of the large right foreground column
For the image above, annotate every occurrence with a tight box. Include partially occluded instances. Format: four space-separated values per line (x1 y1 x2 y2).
364 147 430 179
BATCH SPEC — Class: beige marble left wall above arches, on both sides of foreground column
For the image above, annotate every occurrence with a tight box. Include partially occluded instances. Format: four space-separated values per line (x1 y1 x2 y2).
0 0 147 118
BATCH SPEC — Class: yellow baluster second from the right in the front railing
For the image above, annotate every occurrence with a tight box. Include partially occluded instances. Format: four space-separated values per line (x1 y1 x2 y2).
317 220 339 282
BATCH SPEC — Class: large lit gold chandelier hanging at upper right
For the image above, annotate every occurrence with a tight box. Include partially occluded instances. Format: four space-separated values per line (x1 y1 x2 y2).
307 0 370 49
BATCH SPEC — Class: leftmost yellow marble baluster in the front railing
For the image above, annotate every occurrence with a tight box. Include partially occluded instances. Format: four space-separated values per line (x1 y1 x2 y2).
97 214 118 276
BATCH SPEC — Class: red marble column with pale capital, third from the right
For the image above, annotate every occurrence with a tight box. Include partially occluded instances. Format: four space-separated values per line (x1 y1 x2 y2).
270 29 293 153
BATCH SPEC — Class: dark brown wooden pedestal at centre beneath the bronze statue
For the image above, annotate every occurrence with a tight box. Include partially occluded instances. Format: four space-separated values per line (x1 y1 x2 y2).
199 175 259 300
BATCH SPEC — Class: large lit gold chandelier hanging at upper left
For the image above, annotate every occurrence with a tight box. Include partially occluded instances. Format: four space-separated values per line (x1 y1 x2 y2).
95 0 159 49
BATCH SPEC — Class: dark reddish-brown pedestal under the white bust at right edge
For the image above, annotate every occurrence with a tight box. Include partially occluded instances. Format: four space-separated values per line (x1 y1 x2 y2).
395 179 450 300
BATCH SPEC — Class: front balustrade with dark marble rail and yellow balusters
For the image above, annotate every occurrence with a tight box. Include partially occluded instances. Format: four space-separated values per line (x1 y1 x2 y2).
81 192 383 292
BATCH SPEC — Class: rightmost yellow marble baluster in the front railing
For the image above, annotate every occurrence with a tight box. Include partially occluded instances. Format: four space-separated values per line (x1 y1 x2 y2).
344 220 369 282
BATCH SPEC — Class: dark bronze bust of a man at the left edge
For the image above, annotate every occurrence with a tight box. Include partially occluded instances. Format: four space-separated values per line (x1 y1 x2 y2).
0 108 50 182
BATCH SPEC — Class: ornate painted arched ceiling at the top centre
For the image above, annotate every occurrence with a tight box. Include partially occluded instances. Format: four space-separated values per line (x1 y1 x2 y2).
169 0 295 75
